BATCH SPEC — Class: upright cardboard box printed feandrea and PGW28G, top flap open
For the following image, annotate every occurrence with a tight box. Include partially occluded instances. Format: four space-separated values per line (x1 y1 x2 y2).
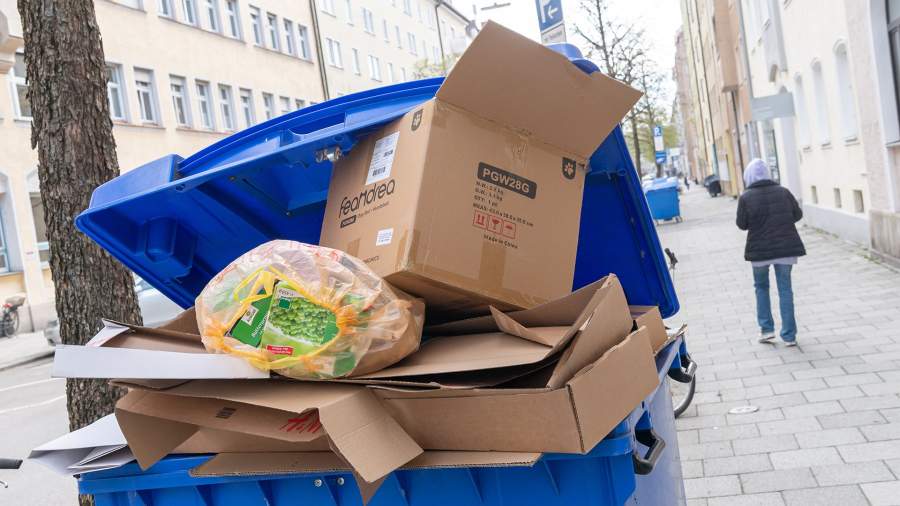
320 23 640 316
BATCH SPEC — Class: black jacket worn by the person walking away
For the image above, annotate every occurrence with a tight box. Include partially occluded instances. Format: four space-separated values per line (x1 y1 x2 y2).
737 179 806 261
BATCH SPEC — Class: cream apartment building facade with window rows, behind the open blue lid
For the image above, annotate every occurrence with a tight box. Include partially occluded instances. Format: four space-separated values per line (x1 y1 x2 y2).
0 0 474 330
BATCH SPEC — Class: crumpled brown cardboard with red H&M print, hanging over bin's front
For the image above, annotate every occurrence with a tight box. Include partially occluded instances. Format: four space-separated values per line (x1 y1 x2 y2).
116 380 422 483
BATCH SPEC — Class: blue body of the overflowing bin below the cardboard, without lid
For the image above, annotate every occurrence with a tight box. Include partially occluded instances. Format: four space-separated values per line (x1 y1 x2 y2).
78 339 685 506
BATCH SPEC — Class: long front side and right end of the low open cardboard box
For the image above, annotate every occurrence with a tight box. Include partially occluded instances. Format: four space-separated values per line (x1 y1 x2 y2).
374 328 659 453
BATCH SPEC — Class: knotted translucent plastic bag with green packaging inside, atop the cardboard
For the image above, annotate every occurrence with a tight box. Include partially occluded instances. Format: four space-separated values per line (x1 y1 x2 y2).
196 240 424 378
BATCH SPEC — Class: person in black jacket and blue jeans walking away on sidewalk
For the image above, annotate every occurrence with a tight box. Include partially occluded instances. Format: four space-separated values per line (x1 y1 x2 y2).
737 158 806 346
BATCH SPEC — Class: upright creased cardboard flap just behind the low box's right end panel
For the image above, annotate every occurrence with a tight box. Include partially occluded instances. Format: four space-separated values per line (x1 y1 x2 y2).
547 283 632 388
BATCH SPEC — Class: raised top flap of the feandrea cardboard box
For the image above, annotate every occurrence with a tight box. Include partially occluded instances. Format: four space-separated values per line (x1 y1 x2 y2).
437 22 641 158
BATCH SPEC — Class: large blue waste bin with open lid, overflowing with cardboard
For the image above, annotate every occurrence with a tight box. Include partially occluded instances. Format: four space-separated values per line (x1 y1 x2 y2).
76 45 684 506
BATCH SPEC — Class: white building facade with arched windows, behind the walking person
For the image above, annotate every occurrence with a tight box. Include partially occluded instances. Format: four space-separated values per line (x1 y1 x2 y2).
743 0 869 244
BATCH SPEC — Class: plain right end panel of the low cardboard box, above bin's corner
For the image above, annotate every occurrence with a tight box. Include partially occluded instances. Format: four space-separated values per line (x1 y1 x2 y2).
568 328 659 449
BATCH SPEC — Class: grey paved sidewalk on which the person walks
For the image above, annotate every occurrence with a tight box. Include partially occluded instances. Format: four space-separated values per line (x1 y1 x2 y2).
658 189 900 506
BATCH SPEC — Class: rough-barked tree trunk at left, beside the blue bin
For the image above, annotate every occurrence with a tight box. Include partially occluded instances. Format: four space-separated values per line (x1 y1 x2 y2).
18 0 141 504
